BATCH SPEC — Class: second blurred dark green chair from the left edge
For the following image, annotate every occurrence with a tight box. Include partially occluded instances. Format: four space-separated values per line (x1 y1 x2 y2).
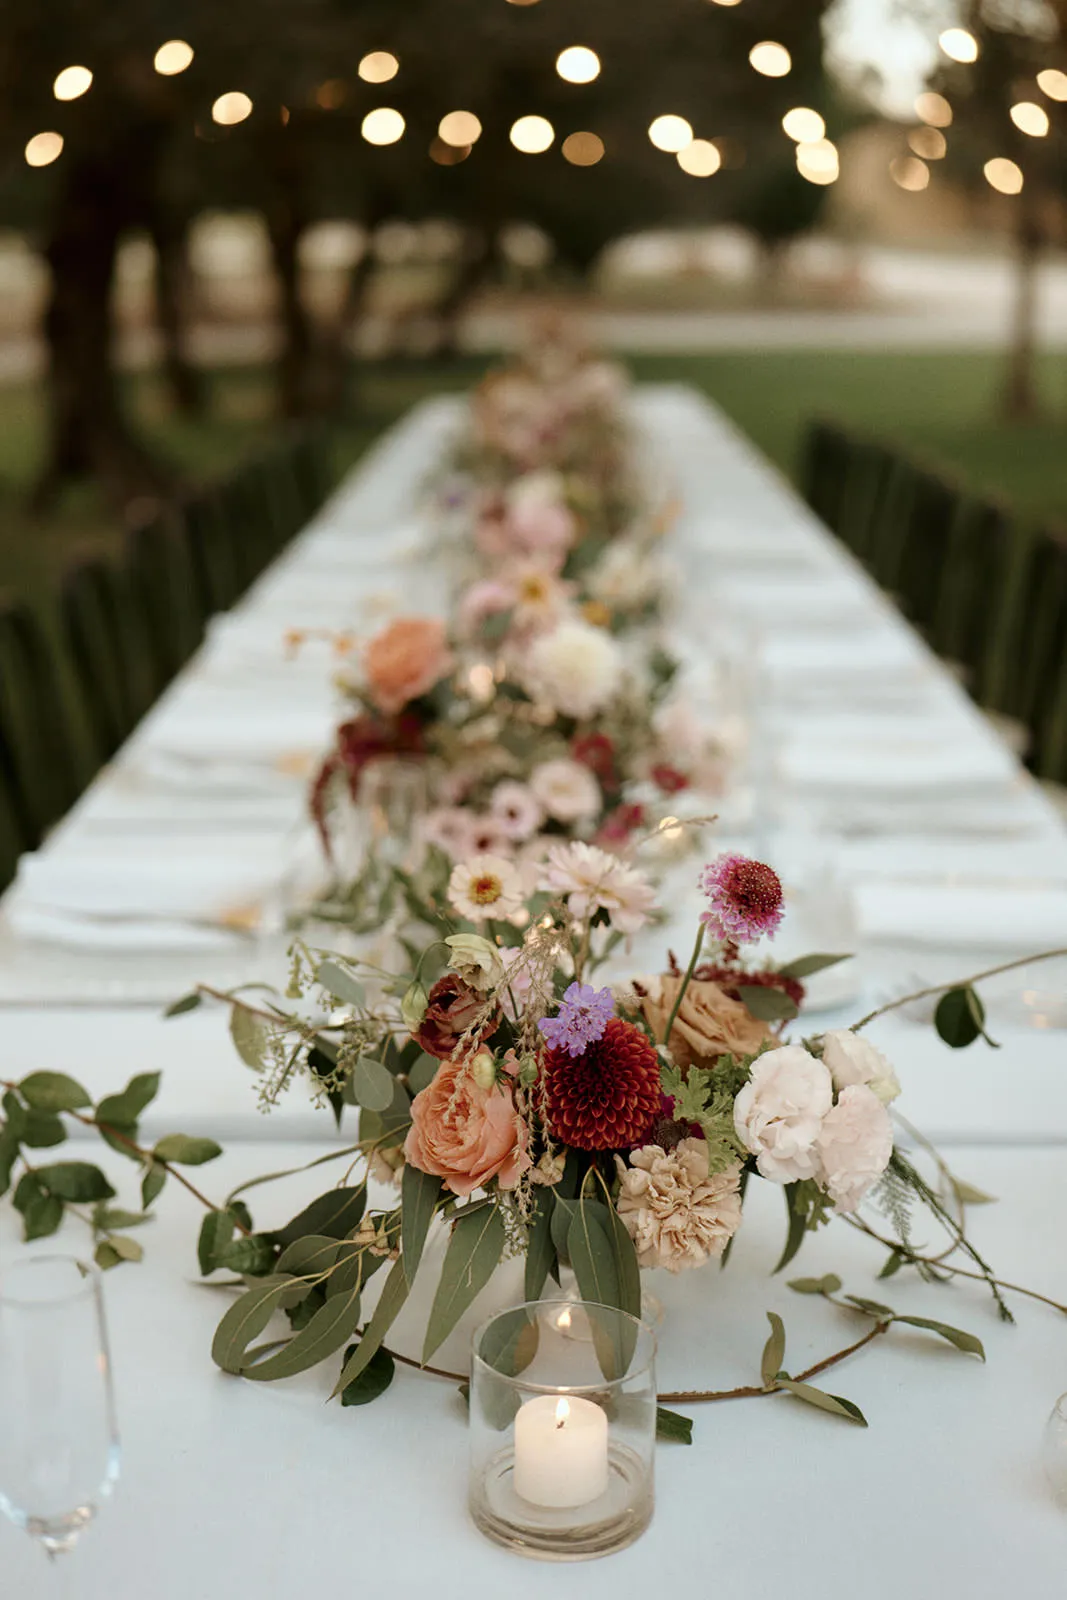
59 558 155 760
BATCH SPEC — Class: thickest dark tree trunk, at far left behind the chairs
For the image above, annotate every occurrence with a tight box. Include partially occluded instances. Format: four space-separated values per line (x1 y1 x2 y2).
30 130 166 512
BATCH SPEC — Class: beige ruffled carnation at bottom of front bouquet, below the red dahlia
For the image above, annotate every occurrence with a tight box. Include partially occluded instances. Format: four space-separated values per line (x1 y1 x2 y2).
617 1139 741 1272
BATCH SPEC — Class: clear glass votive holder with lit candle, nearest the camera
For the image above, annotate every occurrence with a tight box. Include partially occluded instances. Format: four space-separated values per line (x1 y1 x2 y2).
470 1299 656 1562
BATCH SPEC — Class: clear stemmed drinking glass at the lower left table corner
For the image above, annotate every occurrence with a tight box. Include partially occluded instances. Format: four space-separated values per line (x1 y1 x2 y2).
0 1256 118 1557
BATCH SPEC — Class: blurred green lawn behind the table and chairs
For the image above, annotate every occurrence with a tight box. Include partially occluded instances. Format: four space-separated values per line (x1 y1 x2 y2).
0 350 1067 598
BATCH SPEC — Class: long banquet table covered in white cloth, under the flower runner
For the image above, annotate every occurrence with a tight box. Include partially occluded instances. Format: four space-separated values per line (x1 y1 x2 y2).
0 386 1067 1600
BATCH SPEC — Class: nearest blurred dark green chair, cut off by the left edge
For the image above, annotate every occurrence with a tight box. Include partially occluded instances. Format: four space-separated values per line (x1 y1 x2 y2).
0 602 88 850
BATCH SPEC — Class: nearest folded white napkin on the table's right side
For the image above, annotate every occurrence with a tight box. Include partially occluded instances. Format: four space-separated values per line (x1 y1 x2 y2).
856 883 1067 955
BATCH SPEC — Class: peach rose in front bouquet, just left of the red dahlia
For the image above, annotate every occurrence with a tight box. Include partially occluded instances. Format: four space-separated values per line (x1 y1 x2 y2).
403 1059 530 1195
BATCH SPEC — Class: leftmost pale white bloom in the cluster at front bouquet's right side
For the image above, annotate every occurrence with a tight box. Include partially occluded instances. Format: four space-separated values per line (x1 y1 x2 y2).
734 1045 833 1184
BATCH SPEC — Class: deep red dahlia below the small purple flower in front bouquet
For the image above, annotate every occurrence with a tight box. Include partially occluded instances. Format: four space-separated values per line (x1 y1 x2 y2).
544 1016 661 1150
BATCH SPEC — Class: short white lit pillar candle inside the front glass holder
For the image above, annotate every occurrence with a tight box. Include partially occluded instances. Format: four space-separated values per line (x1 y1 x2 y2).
515 1395 608 1509
